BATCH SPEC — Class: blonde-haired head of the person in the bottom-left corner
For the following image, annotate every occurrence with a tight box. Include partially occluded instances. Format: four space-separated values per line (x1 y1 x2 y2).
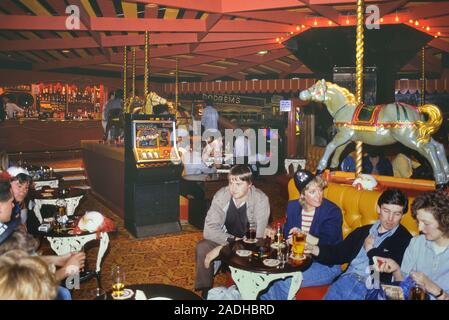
0 250 58 300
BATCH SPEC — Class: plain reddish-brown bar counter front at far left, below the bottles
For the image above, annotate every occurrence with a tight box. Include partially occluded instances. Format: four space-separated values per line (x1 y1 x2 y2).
0 118 103 153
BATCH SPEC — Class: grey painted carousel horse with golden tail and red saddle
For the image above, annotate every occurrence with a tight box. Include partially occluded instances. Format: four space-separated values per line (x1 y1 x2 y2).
299 79 449 188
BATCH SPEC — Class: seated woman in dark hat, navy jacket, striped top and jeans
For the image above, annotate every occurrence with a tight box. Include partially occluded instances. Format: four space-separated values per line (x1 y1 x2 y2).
261 170 343 300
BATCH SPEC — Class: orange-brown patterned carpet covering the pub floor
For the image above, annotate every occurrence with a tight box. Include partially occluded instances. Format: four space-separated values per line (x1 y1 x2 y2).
39 177 286 299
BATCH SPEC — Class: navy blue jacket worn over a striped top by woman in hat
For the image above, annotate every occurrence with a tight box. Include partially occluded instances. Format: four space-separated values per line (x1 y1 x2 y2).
284 199 343 244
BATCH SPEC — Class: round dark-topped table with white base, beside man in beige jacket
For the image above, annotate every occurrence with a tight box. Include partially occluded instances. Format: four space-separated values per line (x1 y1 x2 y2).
220 239 312 300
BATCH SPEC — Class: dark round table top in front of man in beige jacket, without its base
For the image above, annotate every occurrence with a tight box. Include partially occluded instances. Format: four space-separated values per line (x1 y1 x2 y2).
220 239 312 274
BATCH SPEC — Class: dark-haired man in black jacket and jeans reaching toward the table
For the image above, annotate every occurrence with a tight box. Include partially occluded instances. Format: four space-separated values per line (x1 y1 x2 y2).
305 189 412 300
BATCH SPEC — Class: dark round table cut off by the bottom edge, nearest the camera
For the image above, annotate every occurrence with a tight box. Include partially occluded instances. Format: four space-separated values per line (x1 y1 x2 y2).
103 283 202 300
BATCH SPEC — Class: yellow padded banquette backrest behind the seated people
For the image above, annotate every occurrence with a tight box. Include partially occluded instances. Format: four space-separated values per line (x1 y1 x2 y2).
288 179 418 237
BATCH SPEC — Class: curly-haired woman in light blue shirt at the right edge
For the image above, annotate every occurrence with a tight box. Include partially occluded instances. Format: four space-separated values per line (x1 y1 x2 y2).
378 191 449 300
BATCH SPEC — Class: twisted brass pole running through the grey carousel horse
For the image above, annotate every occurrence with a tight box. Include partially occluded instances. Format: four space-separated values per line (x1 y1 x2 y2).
355 0 365 177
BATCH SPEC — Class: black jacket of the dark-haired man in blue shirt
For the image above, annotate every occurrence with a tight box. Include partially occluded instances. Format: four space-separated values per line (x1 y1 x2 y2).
316 224 412 283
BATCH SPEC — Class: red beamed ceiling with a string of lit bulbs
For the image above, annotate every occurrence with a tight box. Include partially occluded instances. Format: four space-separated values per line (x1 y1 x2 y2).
0 0 449 81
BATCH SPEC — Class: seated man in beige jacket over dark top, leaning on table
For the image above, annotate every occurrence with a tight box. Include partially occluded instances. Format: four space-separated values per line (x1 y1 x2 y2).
195 165 270 297
